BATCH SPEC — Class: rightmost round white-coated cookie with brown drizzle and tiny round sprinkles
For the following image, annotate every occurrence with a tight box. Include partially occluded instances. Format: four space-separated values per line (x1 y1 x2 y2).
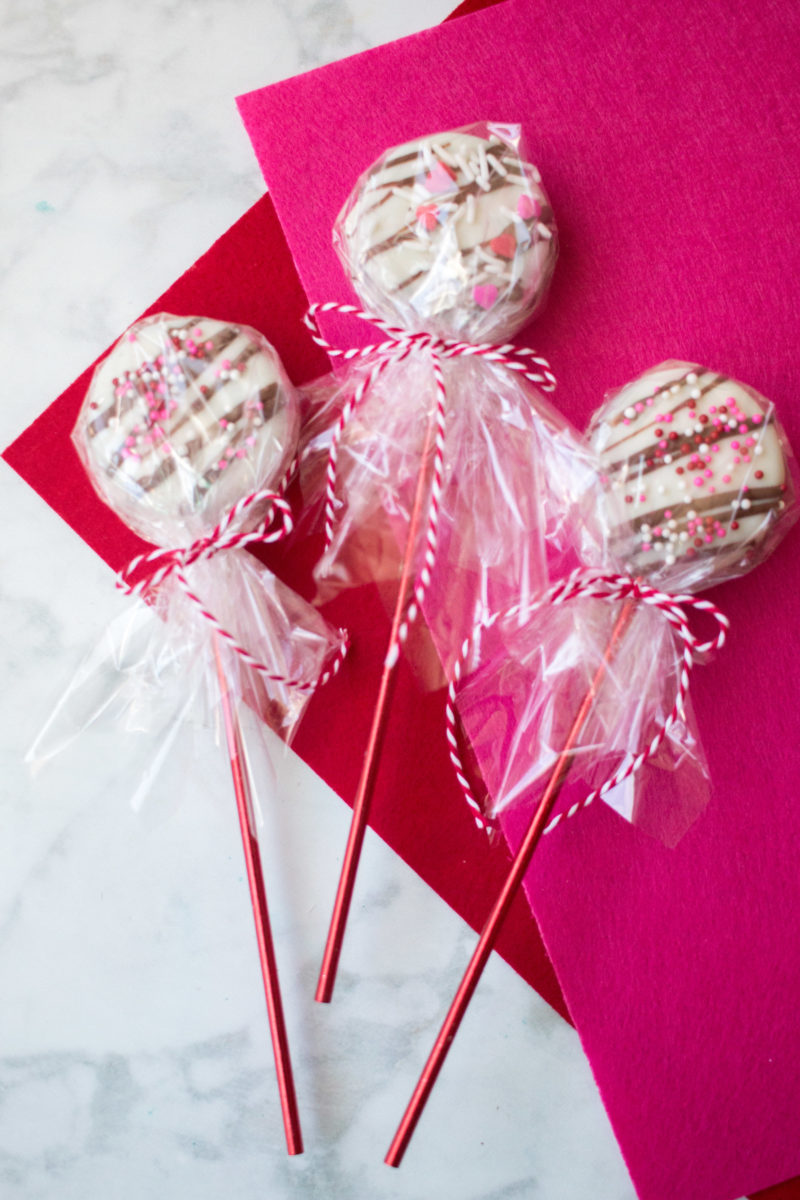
589 362 794 589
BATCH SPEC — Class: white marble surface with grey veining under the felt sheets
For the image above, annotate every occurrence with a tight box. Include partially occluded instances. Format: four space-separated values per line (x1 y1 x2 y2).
0 0 657 1200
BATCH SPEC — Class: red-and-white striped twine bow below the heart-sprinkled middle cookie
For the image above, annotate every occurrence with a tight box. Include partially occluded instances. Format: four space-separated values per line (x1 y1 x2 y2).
303 300 555 666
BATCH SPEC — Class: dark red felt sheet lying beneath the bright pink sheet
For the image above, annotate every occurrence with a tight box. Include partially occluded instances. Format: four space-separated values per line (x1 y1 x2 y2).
4 169 566 1016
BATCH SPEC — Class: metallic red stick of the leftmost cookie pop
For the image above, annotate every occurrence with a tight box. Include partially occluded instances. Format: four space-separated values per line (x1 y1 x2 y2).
213 636 302 1154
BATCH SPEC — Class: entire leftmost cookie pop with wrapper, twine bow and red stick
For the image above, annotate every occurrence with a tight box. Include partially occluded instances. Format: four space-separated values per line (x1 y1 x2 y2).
67 313 347 1154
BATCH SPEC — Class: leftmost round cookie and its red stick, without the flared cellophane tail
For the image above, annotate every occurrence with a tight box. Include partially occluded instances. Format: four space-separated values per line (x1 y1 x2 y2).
72 313 302 1154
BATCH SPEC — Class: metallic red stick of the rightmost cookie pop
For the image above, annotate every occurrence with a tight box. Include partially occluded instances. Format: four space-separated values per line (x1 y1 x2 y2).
384 599 634 1166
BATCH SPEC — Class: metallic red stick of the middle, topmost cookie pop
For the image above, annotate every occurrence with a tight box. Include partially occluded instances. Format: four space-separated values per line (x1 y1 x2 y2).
314 414 435 1004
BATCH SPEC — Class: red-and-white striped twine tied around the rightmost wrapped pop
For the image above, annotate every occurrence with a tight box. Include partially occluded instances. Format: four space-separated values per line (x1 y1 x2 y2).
445 568 730 833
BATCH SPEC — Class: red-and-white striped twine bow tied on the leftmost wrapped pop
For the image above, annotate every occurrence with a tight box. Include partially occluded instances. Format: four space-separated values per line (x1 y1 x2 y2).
116 490 349 691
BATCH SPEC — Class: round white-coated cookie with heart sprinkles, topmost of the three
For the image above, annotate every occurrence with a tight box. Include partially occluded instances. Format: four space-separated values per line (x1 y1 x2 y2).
335 125 558 341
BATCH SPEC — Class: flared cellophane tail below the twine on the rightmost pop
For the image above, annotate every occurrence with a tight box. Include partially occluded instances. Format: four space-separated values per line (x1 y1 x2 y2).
456 598 710 845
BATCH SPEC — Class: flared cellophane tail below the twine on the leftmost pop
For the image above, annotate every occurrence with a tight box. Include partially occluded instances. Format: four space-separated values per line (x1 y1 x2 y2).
28 550 342 802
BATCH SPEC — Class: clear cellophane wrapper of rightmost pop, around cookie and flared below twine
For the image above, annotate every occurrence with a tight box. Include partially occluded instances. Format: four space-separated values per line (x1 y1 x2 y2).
457 361 798 845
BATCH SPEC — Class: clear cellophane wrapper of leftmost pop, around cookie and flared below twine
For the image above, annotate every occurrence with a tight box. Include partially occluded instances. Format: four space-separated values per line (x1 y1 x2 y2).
28 314 342 798
